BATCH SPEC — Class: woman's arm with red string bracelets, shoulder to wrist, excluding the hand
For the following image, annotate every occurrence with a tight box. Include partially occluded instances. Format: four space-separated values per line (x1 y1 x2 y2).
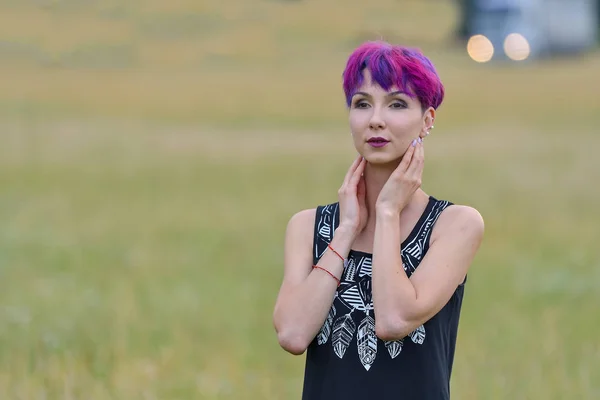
273 209 354 355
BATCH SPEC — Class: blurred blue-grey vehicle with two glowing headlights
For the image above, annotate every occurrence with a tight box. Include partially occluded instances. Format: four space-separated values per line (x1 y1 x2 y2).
459 0 600 62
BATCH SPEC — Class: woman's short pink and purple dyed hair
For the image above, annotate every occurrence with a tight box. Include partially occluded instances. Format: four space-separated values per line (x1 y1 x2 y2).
343 41 445 110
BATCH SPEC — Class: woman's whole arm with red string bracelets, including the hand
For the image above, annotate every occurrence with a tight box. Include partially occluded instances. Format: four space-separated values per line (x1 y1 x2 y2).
273 156 367 354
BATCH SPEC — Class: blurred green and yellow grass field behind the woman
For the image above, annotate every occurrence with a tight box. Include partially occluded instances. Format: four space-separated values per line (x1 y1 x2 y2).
0 0 600 400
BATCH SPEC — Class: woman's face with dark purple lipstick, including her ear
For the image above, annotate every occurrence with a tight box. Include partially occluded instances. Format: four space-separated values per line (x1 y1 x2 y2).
349 69 435 164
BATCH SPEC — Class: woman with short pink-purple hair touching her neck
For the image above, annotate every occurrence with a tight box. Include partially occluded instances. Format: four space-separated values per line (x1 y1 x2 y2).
273 42 484 400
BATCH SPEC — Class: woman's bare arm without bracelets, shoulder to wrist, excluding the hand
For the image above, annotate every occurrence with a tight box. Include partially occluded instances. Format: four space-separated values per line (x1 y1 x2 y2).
373 206 484 340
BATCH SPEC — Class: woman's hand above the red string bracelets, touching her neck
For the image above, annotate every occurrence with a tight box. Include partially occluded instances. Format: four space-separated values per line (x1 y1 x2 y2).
338 155 368 236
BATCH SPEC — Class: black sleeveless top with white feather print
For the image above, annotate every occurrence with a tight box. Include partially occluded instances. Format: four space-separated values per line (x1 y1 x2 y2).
302 196 466 400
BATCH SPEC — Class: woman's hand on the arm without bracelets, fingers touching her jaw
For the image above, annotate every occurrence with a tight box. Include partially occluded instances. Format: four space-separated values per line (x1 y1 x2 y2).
375 138 425 213
